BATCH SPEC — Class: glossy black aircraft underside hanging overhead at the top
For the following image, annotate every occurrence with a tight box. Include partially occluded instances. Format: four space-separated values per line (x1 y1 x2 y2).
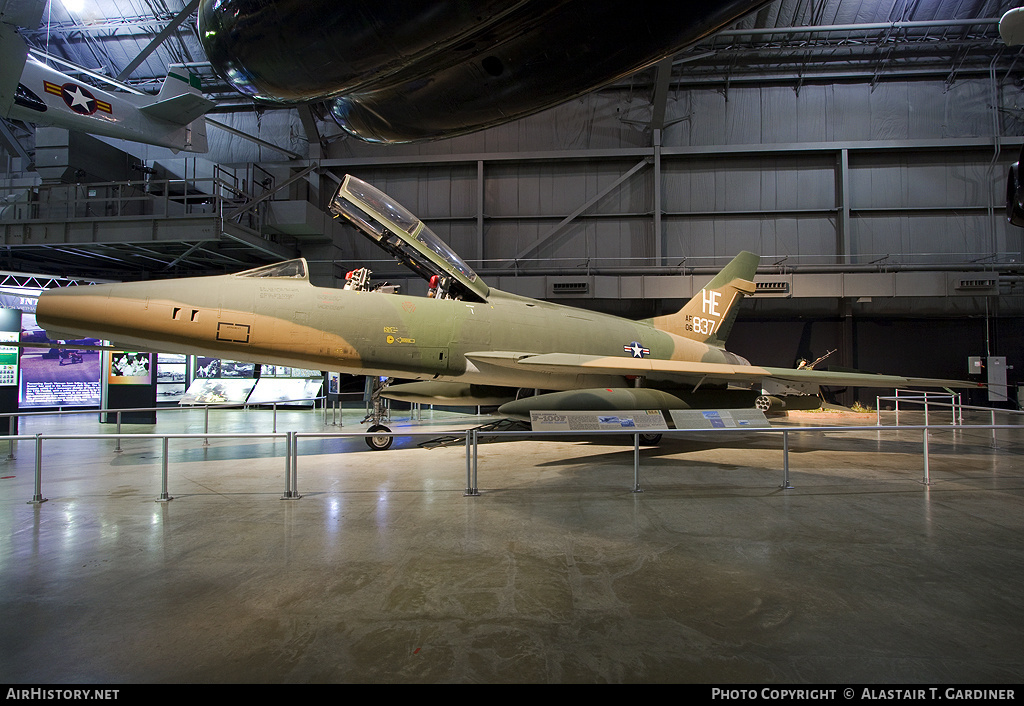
199 0 766 142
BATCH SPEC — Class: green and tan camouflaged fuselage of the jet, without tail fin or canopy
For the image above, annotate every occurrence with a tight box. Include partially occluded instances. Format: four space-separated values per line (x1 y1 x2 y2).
37 275 741 389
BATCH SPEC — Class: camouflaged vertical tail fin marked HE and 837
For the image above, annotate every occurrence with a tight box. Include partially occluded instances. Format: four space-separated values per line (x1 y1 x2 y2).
649 251 761 347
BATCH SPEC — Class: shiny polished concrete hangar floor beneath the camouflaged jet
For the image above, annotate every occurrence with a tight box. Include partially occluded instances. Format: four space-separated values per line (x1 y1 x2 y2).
0 411 1024 683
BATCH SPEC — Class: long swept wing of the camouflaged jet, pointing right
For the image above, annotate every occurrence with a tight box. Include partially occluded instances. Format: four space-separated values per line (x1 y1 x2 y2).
466 351 984 388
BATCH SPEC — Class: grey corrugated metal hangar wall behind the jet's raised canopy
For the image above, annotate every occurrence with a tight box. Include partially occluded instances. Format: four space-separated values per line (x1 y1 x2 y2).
317 74 1021 268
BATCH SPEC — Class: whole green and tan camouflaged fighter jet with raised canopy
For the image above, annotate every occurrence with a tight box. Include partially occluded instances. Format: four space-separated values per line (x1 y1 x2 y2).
36 176 975 449
